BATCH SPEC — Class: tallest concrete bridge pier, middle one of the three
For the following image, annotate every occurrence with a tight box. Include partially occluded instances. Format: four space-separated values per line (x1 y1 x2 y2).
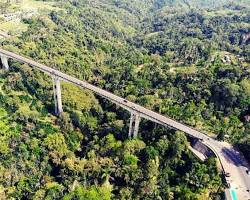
53 76 63 116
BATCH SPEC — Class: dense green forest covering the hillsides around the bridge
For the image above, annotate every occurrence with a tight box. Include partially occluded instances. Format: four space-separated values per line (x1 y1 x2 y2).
0 0 250 200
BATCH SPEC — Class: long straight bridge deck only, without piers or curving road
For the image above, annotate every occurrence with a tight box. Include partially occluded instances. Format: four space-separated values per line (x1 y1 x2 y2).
0 49 207 139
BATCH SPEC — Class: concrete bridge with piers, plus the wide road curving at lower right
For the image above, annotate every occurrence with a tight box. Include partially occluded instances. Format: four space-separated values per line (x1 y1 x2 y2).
0 49 250 200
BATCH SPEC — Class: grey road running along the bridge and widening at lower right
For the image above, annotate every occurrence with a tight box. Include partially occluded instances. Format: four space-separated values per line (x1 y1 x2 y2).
0 49 250 200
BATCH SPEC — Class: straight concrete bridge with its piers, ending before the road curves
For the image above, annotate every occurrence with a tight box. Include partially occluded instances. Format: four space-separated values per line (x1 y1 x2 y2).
0 49 207 139
